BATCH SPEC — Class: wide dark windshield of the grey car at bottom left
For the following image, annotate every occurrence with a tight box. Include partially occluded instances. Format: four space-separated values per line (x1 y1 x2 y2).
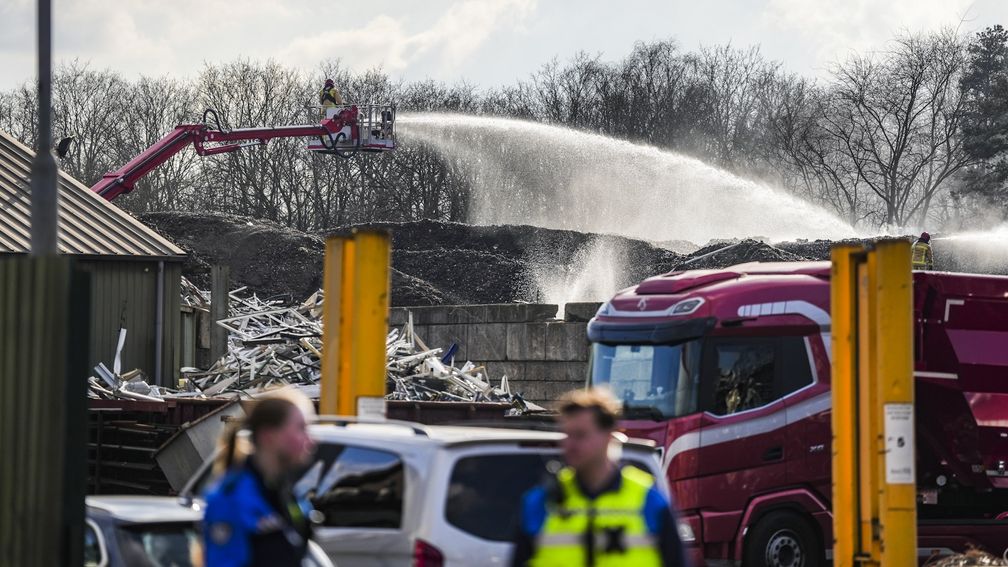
118 522 203 567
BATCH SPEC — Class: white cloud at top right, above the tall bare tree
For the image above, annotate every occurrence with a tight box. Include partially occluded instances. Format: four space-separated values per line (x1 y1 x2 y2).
762 0 973 70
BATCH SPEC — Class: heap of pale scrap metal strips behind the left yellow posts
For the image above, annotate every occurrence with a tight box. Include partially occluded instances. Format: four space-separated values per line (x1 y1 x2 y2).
89 277 535 412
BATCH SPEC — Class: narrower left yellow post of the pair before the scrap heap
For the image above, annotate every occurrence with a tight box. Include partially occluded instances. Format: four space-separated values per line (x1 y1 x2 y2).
319 236 347 415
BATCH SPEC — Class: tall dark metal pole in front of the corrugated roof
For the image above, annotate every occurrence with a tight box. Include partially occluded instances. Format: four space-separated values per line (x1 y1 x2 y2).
31 0 59 256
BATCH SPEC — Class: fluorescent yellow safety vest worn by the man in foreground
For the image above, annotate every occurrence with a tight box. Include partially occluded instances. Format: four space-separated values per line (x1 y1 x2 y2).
528 466 661 567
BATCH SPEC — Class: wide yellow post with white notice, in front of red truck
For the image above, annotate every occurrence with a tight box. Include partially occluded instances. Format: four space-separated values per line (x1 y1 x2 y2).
872 240 917 566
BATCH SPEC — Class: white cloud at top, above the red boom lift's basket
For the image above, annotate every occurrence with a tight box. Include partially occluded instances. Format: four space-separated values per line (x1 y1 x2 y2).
278 0 535 72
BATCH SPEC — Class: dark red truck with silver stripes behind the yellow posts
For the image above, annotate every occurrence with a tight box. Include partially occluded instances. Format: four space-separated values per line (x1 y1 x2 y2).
588 262 1008 567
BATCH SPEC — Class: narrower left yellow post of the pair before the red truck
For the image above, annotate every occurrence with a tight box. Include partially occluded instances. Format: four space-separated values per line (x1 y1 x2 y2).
830 246 864 567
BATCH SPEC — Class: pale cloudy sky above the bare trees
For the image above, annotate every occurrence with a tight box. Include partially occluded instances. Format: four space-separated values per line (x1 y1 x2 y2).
0 0 1008 89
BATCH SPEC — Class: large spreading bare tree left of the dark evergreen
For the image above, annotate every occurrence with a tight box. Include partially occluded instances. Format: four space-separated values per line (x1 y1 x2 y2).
830 30 969 226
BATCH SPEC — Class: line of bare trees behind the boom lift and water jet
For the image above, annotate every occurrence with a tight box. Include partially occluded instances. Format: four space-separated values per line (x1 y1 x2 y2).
0 26 1008 230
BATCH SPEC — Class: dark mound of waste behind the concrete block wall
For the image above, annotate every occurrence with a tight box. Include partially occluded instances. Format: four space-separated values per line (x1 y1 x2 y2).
140 212 1005 306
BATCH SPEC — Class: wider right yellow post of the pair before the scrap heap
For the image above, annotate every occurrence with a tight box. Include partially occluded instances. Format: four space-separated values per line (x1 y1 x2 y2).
340 229 391 417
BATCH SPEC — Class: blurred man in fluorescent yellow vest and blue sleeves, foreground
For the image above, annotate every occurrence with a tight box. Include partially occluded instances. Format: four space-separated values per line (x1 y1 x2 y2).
511 389 686 567
